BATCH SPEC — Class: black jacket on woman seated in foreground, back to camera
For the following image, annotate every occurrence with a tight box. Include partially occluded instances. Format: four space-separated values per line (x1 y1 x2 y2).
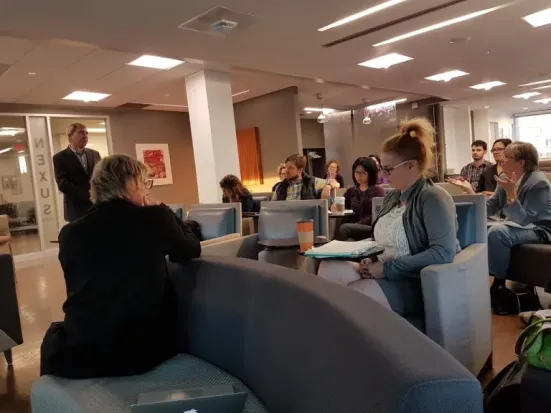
41 199 201 378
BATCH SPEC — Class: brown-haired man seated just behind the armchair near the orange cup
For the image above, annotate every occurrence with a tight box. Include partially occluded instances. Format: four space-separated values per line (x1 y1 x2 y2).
272 154 339 201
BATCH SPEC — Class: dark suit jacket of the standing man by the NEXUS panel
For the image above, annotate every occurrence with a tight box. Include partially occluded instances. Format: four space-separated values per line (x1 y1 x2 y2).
53 147 101 222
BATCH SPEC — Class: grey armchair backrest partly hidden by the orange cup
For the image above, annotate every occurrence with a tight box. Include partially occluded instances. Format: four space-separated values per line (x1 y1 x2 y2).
258 200 329 240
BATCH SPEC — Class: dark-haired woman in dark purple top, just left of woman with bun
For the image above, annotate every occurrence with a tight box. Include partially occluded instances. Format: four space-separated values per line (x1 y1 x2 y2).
336 157 385 241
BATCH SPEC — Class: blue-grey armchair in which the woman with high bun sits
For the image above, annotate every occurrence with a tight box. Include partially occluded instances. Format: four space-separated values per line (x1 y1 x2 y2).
373 195 492 374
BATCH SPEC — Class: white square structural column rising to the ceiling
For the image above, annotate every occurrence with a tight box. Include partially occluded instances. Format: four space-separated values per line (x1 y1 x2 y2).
186 70 240 204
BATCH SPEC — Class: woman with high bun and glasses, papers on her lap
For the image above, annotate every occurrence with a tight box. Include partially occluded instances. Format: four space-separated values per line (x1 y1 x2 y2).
320 119 459 318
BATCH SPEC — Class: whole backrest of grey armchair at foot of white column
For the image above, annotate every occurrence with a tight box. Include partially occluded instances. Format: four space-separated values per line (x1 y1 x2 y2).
187 202 242 240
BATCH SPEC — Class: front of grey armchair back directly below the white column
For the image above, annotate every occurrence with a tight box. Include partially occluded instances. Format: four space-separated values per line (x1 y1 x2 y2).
187 208 235 240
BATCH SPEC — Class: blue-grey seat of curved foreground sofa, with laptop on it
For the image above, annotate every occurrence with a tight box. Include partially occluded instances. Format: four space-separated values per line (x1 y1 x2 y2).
31 354 267 413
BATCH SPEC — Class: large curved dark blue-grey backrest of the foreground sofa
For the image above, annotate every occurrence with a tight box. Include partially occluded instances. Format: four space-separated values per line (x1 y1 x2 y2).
170 257 482 413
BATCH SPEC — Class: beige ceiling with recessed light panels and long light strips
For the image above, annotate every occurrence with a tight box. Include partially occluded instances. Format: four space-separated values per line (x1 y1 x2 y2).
0 0 551 110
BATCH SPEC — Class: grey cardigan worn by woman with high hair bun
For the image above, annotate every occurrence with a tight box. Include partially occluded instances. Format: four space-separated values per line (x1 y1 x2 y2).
373 178 459 279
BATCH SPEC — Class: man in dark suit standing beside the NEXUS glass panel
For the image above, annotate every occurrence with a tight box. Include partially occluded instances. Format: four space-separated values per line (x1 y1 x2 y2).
54 123 101 222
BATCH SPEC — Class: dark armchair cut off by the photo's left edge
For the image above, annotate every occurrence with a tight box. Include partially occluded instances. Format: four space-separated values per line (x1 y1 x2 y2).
0 254 23 365
